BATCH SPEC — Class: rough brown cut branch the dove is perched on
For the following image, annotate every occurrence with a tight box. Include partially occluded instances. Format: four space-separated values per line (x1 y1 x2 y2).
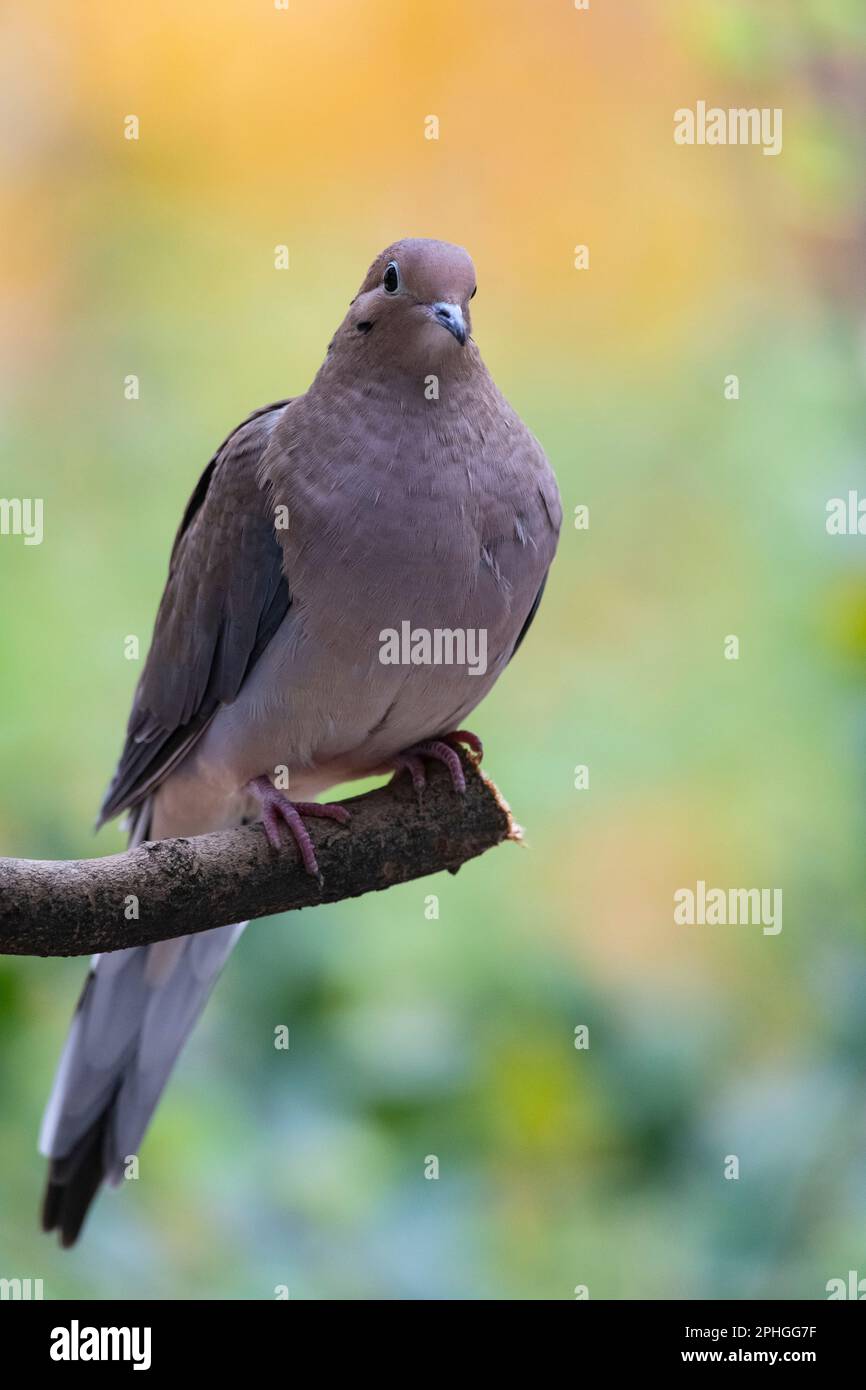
0 753 520 956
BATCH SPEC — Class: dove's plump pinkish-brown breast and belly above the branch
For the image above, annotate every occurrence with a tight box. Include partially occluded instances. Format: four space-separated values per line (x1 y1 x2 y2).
184 375 559 796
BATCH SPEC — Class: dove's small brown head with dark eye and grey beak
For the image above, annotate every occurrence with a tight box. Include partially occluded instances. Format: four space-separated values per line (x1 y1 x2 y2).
338 236 475 370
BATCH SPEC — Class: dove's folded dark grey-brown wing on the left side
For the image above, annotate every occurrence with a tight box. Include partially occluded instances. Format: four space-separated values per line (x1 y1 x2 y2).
99 400 291 826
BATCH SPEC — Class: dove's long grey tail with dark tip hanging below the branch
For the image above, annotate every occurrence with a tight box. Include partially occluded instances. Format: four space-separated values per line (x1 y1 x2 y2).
39 800 246 1245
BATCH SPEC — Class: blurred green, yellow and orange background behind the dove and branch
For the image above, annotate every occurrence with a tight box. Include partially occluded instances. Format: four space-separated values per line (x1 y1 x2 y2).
0 0 866 1298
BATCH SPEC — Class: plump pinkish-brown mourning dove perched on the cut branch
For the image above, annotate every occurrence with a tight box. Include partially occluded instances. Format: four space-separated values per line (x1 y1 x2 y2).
40 239 562 1245
